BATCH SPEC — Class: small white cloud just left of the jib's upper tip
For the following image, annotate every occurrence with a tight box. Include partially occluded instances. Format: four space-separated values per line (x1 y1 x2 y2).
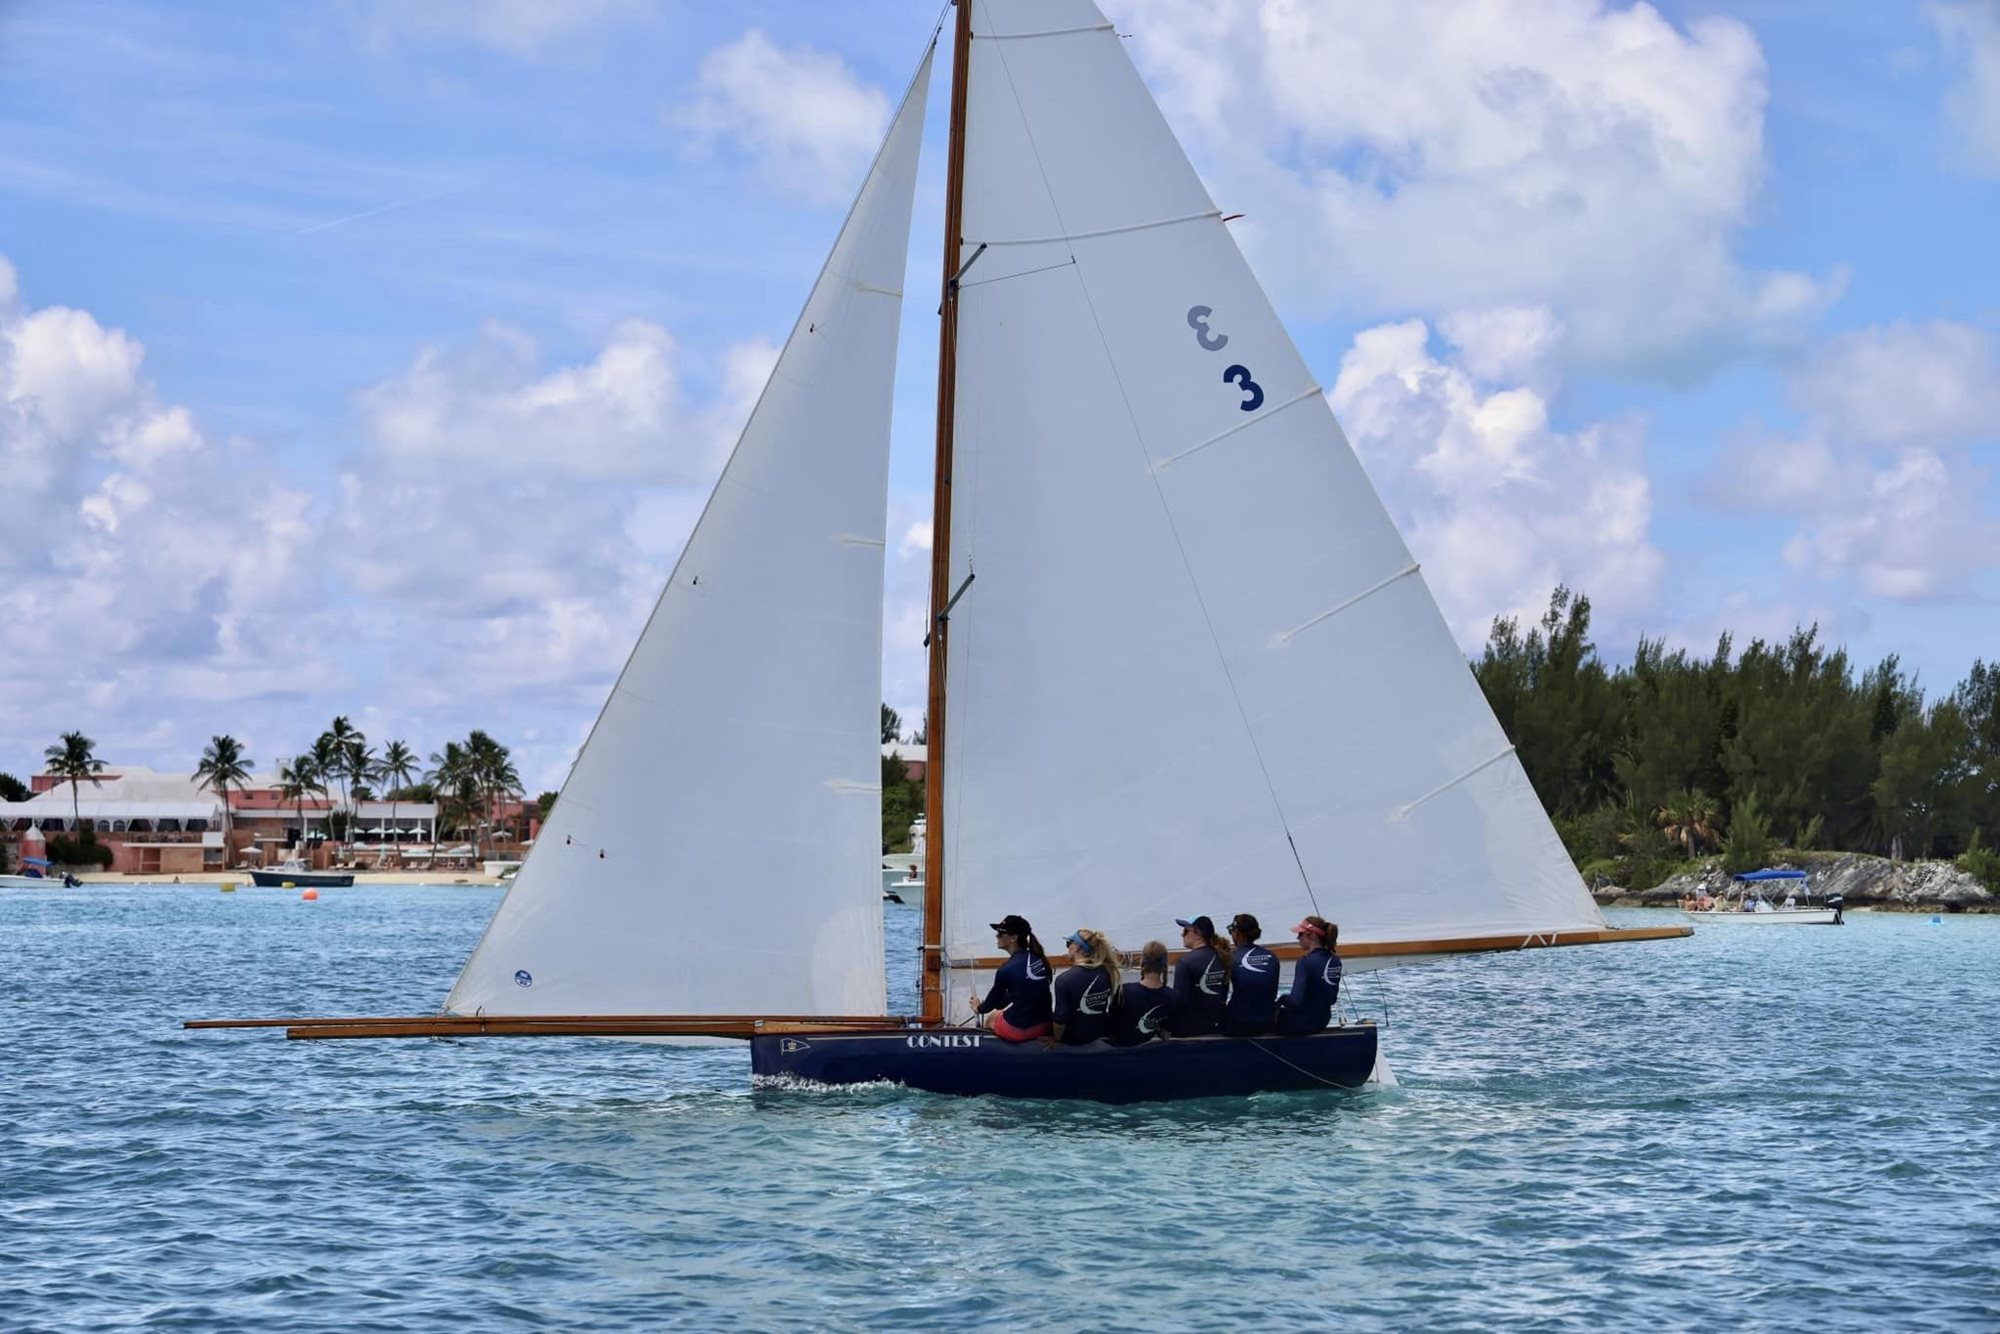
666 28 890 204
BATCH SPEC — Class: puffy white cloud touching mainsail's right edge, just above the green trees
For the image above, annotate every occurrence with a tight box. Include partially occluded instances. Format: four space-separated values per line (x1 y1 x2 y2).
1328 312 1662 648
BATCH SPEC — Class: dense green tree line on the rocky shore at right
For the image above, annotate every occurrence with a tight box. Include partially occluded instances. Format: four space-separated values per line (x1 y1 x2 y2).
1472 588 2000 888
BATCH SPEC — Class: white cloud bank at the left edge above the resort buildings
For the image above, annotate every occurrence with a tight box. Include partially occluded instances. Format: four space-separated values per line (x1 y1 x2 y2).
0 260 324 752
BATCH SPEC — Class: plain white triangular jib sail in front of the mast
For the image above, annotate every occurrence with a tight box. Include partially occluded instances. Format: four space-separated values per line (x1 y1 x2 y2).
446 54 930 1014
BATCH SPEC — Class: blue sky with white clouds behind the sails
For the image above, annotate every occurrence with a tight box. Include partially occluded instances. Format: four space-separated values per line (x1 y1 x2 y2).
0 0 2000 790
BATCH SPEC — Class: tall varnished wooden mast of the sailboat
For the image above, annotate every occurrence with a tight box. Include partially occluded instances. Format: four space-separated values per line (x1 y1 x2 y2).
918 0 972 1020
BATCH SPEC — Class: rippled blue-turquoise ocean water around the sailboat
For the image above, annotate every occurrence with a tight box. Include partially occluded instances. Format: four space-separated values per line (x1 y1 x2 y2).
0 886 2000 1330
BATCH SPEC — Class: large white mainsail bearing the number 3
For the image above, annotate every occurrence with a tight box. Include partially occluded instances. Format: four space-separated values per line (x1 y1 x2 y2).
944 0 1604 1000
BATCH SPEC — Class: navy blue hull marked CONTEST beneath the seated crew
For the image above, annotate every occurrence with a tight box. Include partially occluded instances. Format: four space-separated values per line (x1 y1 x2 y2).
750 1024 1376 1102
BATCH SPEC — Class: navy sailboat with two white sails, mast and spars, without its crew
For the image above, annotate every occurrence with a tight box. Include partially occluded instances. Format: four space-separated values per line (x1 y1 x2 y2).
196 0 1690 1102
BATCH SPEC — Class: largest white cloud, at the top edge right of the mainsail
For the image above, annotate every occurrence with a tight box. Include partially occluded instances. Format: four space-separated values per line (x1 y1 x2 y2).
1116 0 1842 372
